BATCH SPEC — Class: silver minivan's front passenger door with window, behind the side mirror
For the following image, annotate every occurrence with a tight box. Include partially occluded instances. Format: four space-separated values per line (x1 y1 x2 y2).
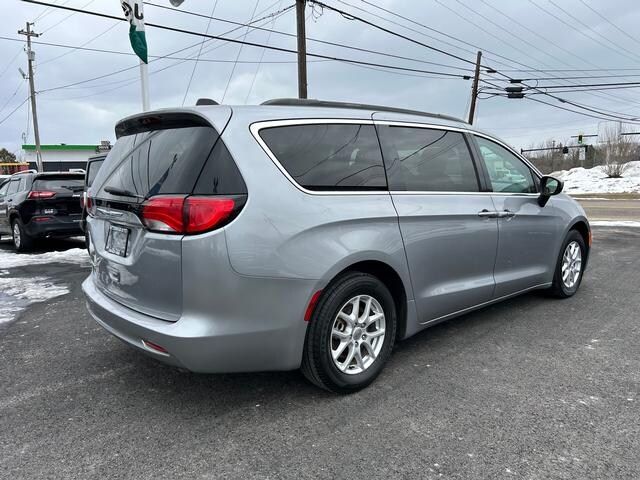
474 136 560 298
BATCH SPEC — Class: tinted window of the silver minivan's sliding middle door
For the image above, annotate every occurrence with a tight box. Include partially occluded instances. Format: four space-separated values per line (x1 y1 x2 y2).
378 125 480 192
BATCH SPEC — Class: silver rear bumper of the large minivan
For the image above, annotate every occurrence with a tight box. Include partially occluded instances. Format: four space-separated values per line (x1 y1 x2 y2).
82 276 307 373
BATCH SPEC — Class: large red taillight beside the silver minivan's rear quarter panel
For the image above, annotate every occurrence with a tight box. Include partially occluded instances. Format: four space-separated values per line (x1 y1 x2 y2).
140 196 244 234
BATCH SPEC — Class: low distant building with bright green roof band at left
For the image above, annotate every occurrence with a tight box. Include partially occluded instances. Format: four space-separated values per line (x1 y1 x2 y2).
22 141 111 172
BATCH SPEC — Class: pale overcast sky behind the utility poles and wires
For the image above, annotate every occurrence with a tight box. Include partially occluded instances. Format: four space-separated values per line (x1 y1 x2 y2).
0 0 640 156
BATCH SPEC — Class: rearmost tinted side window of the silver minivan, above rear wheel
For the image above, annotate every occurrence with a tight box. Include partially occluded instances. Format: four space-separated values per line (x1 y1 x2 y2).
260 124 387 190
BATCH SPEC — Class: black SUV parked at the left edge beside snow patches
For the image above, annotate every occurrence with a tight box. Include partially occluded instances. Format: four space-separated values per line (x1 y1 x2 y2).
0 170 83 252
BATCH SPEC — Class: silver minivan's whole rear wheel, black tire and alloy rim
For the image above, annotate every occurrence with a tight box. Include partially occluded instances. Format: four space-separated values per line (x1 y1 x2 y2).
302 272 397 393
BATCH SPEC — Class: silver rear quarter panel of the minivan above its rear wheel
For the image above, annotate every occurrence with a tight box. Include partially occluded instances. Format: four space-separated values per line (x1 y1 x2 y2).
223 115 413 298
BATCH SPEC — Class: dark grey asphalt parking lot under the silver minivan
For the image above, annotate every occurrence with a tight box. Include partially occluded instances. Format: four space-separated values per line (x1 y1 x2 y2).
0 228 640 479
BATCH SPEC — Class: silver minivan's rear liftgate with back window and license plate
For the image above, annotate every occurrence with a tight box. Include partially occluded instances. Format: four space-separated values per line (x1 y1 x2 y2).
87 107 231 321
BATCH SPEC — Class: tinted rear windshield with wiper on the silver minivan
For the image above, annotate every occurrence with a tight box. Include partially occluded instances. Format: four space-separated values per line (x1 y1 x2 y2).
93 126 218 202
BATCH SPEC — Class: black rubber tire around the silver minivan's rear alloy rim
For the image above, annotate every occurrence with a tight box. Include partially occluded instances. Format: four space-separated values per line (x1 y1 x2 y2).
301 272 397 393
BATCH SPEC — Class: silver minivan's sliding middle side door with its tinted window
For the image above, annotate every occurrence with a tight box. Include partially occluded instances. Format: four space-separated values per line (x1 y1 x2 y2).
374 114 498 323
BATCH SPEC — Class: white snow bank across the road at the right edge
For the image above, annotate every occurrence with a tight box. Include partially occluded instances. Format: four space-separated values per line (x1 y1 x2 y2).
551 161 640 194
